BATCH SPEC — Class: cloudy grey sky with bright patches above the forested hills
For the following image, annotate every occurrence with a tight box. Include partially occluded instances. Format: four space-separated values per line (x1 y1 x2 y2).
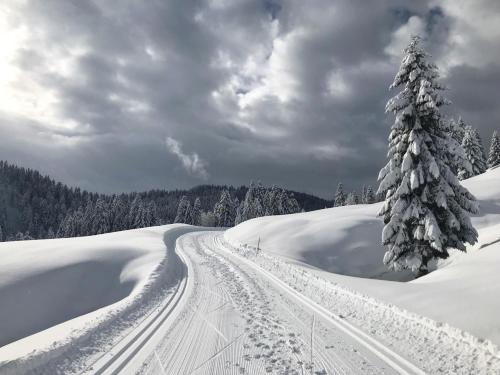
0 0 500 197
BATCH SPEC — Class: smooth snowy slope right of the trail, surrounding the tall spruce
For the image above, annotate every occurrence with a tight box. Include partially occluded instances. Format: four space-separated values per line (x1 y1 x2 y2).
225 168 500 345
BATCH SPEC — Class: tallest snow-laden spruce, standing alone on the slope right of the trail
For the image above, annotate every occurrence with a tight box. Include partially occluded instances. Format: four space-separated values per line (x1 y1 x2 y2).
378 37 478 275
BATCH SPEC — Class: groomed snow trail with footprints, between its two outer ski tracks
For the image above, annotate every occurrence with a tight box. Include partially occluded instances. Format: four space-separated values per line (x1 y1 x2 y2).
92 232 423 374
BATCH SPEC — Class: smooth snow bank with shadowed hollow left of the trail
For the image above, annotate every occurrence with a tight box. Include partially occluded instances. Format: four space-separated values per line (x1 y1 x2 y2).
0 225 189 362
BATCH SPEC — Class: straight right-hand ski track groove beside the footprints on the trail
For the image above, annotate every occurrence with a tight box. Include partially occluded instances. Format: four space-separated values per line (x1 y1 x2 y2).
213 235 426 375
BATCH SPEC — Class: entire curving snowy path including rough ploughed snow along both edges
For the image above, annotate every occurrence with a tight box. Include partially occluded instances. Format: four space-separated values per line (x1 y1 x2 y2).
0 226 500 375
